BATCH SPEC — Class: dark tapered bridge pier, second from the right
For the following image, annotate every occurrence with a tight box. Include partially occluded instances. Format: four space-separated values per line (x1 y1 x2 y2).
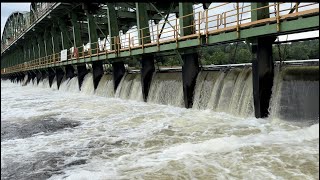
181 53 199 108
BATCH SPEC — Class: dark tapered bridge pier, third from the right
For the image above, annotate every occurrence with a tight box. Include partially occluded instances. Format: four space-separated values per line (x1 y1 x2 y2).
141 55 155 102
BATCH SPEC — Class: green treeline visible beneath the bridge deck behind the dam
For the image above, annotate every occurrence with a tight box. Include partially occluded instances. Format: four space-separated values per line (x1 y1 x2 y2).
158 39 319 66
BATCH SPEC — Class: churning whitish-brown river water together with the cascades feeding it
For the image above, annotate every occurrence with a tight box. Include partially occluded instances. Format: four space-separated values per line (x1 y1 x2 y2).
1 68 319 180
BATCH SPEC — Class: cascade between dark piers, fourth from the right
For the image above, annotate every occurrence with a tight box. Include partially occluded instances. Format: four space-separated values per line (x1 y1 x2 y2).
115 73 143 101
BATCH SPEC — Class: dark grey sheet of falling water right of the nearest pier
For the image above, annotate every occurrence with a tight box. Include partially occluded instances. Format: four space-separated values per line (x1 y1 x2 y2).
269 66 319 123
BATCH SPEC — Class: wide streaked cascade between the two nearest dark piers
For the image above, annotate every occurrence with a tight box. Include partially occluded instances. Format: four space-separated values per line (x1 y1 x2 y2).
193 68 253 116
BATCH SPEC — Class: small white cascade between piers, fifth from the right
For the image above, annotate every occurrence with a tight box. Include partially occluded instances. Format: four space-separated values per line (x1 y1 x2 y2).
95 74 114 97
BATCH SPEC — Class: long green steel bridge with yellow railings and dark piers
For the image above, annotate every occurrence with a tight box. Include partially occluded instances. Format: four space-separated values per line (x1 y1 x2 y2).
1 2 319 117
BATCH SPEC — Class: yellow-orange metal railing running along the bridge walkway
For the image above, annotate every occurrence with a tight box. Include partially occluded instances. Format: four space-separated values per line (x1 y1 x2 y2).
1 3 319 74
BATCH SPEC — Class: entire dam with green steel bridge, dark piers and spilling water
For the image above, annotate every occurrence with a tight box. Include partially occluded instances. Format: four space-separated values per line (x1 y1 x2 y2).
1 3 319 120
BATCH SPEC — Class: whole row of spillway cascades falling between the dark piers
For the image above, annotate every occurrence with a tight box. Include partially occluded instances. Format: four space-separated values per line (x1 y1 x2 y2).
8 65 319 121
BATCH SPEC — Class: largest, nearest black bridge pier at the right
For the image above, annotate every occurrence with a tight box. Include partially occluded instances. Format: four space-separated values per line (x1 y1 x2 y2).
252 37 274 118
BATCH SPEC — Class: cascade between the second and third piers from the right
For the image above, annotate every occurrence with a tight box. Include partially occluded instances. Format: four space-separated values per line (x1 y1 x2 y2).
148 72 184 107
